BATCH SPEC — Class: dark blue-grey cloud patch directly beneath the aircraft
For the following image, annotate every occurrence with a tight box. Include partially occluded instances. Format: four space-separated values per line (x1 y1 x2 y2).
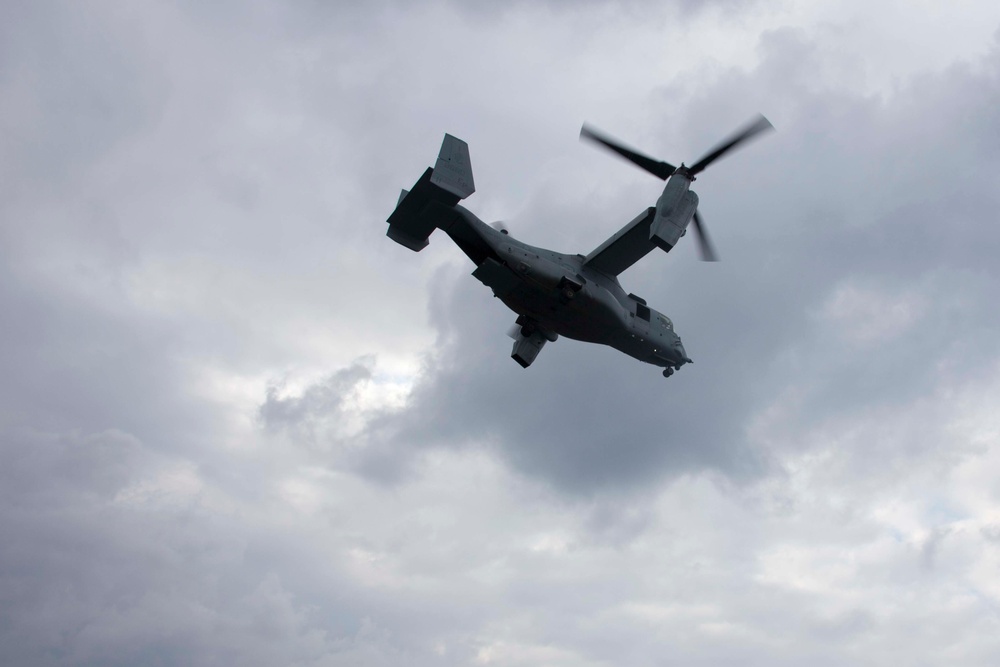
362 272 772 494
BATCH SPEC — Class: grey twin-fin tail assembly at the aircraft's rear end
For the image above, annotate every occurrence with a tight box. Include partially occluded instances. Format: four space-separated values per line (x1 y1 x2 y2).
386 134 476 251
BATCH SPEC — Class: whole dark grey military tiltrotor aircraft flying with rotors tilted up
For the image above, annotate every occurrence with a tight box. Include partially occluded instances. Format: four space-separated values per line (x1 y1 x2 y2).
387 116 771 377
